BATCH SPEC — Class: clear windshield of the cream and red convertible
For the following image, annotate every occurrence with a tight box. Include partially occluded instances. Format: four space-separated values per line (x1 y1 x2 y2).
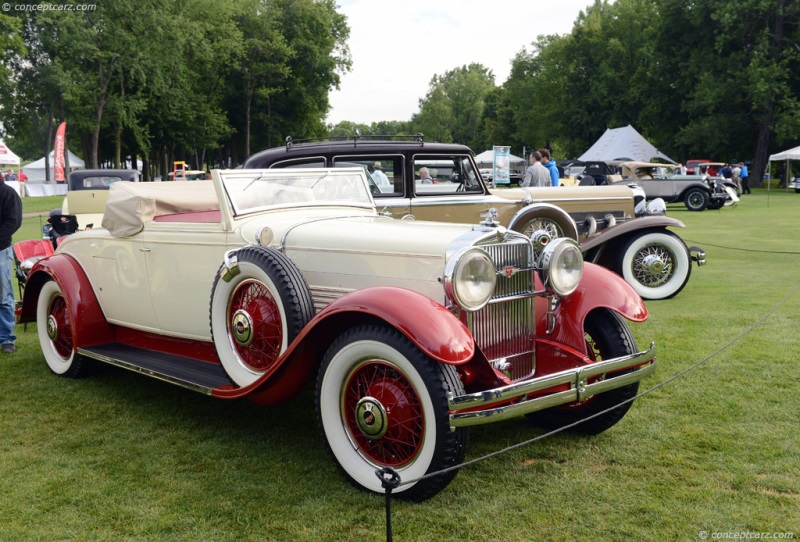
222 168 374 216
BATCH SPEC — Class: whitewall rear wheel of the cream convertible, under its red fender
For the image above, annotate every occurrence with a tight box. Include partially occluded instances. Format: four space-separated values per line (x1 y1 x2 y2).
36 280 89 378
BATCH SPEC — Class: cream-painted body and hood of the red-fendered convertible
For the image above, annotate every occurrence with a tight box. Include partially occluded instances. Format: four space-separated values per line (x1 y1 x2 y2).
58 169 478 341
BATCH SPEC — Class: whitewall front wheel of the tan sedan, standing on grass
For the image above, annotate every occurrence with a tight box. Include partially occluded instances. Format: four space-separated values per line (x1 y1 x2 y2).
616 231 692 299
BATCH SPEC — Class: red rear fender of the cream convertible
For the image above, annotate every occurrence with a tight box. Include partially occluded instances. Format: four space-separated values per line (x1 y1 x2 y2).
20 254 114 347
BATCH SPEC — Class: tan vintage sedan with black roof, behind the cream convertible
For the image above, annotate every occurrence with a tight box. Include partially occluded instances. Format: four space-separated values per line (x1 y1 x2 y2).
244 138 705 299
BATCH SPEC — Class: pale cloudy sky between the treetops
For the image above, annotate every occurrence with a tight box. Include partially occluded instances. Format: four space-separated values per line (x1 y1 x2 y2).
327 0 594 124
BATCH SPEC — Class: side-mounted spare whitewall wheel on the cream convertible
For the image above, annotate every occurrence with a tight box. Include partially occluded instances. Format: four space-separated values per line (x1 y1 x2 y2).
210 247 314 392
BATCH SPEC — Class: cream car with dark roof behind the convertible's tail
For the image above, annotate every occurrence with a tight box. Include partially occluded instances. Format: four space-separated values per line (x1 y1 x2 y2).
42 169 141 246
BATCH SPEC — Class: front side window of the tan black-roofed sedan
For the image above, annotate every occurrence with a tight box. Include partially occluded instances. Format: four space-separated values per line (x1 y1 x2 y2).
414 155 483 196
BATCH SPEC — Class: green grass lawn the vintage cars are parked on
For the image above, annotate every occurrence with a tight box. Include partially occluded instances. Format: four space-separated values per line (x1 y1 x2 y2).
0 190 800 541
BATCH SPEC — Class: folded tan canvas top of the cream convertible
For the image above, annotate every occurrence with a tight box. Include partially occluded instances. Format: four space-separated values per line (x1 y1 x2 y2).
103 181 219 237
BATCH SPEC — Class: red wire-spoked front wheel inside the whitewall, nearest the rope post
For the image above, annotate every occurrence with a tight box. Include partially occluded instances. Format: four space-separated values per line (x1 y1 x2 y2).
342 361 425 467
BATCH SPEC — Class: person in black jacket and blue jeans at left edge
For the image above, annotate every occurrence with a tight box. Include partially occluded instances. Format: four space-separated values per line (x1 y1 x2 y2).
0 175 22 354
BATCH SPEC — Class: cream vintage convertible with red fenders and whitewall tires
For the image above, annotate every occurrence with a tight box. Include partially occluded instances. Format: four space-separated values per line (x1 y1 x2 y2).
22 168 655 500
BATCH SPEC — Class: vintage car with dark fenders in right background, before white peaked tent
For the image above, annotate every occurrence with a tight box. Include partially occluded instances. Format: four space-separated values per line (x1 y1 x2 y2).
620 162 739 211
